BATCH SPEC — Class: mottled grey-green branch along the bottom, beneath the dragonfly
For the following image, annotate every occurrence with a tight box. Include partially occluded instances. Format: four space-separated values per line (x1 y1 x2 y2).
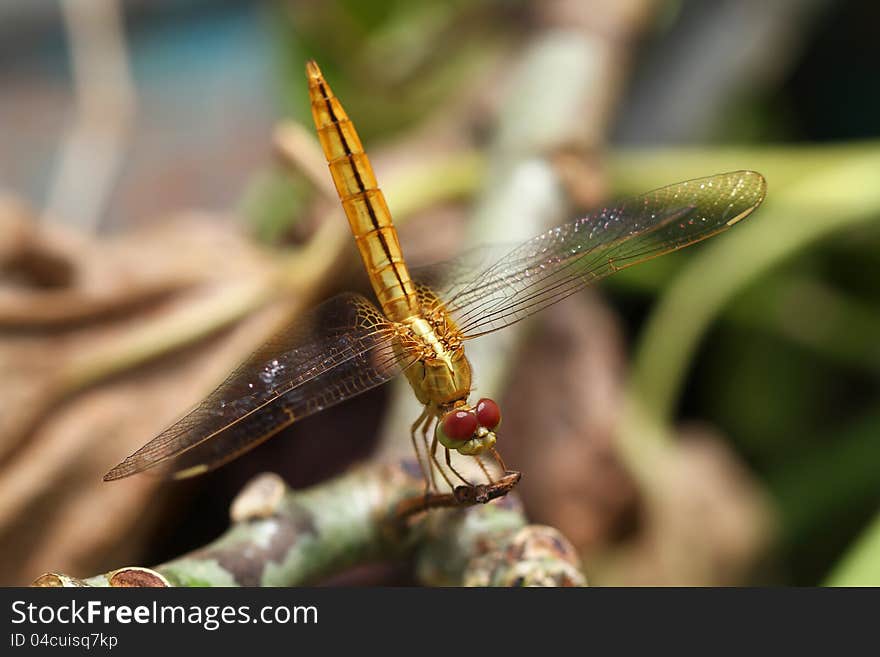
34 461 586 586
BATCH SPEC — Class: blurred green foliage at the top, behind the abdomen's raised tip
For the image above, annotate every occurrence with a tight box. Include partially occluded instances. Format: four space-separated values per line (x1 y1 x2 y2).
271 0 526 139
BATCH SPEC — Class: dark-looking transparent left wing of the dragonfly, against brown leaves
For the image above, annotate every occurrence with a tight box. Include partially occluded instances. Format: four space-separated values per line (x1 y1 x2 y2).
104 294 415 480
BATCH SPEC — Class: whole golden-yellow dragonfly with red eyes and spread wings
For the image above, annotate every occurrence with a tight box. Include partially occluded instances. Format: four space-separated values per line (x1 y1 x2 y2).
104 61 766 500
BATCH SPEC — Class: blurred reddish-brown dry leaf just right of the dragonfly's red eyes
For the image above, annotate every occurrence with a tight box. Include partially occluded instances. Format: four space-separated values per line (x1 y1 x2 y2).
501 293 636 554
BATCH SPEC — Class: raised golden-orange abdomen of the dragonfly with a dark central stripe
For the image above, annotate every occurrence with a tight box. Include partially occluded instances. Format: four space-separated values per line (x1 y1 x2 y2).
307 62 418 321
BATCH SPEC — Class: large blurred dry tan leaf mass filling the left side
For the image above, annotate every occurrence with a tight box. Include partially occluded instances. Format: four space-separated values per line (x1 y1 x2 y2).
0 206 300 584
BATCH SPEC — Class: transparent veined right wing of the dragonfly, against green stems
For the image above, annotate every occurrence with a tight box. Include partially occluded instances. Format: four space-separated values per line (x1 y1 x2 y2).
436 171 767 339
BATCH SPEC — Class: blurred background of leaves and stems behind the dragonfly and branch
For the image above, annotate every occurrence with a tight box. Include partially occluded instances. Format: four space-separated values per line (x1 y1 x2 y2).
0 0 880 585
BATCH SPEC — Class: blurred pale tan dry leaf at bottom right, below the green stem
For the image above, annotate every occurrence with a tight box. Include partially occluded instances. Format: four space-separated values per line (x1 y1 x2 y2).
592 428 774 586
